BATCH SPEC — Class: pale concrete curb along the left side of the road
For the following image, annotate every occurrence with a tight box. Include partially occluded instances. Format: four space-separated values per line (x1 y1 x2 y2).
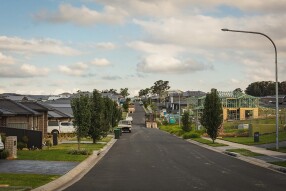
32 138 117 191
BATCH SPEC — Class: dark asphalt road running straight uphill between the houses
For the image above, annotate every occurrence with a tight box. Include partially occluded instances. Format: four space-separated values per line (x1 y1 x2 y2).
66 105 286 191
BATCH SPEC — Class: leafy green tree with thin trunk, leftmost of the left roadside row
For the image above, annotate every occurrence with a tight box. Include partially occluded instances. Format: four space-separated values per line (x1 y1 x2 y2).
71 94 91 150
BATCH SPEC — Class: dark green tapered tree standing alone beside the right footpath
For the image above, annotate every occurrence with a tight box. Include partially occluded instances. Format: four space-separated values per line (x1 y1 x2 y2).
200 89 223 143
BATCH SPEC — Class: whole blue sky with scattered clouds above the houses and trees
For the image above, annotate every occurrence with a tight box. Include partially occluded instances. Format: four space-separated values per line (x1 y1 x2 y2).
0 0 286 95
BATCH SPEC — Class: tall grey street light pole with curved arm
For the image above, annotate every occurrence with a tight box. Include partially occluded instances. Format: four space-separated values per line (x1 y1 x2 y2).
221 29 279 150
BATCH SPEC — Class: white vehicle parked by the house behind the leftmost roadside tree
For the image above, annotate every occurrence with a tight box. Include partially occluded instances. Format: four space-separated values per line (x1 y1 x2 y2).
47 121 75 134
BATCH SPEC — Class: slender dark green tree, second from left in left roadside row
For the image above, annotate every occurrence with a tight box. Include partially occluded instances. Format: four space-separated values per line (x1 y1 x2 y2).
88 89 104 143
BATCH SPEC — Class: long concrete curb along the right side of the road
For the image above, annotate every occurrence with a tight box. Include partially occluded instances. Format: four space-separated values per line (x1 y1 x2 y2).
187 139 286 174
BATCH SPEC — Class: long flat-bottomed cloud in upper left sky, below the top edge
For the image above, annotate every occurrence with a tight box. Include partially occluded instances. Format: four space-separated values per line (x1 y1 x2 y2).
34 4 127 26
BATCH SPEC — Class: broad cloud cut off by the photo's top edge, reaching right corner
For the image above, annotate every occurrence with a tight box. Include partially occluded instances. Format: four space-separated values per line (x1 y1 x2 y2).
94 0 286 17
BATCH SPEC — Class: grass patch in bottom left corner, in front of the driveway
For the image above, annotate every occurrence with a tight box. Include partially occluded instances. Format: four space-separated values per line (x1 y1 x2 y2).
0 173 59 190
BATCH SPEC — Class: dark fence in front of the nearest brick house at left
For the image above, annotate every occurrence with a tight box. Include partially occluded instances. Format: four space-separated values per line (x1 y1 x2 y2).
0 127 43 149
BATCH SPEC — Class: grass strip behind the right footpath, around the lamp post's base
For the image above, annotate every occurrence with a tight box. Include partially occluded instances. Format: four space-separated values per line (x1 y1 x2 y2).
222 131 286 145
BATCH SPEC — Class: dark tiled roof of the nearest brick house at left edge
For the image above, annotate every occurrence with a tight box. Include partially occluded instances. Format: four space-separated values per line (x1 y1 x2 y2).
0 98 40 115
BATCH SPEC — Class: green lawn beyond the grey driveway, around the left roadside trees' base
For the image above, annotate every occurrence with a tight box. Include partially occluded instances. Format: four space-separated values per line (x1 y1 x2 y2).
17 143 105 162
